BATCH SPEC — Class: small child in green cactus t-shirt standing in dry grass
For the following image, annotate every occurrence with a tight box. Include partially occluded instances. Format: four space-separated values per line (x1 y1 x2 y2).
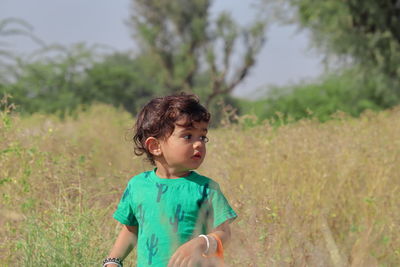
103 94 237 267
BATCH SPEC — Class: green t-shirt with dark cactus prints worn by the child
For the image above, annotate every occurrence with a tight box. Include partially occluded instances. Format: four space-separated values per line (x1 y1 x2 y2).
114 170 237 267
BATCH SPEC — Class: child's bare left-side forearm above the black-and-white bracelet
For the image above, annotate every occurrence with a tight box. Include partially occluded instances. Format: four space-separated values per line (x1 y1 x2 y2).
108 225 138 266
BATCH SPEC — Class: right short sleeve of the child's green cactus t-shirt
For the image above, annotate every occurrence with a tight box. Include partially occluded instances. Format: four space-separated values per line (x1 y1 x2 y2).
210 183 237 228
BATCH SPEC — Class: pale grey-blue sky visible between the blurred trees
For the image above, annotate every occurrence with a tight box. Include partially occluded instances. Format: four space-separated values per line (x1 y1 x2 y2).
0 0 323 97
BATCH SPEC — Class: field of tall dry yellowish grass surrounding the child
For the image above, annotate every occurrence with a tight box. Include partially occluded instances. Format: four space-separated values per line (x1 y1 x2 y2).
0 105 400 266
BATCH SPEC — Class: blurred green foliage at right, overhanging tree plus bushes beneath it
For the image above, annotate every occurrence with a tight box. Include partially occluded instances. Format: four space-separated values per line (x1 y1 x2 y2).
241 0 400 124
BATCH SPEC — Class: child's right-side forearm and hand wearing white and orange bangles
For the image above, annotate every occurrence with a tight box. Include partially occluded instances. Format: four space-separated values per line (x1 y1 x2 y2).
168 221 231 267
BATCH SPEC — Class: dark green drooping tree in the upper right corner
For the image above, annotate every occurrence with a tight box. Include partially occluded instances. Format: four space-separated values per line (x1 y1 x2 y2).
280 0 400 106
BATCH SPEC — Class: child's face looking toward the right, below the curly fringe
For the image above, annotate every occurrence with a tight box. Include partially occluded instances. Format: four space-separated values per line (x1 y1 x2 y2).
157 120 208 178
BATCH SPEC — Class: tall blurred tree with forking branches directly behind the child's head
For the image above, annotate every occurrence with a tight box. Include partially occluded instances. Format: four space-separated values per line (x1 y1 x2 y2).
128 0 265 106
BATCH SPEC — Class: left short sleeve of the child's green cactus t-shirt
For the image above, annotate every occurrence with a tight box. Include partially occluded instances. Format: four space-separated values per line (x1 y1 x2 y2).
113 183 138 226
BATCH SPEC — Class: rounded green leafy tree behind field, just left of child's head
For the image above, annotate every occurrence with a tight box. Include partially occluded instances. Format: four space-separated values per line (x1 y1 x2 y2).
83 53 163 114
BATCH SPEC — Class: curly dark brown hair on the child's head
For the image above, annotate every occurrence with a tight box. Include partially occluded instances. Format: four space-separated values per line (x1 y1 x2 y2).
133 93 211 165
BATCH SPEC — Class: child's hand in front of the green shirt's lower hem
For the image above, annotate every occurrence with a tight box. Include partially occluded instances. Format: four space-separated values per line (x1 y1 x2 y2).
168 237 206 267
